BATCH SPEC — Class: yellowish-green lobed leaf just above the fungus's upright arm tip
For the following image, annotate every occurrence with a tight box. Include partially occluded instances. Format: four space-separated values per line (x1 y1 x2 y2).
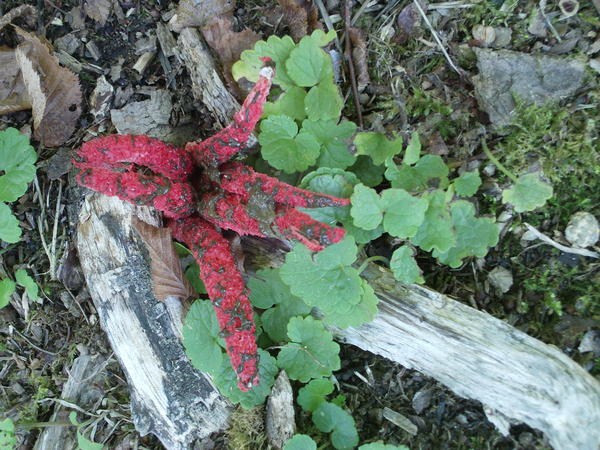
231 36 296 89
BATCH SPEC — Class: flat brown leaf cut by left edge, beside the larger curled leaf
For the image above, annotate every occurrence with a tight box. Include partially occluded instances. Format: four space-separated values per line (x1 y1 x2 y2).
0 47 31 114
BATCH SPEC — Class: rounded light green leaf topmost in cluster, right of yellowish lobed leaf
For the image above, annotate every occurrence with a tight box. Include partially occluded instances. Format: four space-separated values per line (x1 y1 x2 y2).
285 36 331 87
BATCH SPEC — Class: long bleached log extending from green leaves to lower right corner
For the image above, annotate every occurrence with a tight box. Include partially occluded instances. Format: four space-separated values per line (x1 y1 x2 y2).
352 264 600 450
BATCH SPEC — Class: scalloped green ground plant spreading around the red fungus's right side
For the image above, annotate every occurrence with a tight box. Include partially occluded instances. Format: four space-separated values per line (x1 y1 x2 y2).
178 31 564 449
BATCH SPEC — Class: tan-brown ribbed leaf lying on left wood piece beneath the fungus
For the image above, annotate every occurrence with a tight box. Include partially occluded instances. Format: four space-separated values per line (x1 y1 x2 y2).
133 217 196 302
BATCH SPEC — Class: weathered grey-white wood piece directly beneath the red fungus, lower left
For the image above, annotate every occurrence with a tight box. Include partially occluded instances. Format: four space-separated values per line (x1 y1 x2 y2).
77 194 230 449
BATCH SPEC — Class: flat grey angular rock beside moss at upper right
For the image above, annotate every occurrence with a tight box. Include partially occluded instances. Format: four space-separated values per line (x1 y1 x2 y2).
473 48 585 127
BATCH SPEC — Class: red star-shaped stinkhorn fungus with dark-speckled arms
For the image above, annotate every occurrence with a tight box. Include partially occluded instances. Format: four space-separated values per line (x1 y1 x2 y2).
73 67 348 391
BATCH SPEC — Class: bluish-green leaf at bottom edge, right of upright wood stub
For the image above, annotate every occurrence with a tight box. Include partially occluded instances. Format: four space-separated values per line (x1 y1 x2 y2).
312 402 358 449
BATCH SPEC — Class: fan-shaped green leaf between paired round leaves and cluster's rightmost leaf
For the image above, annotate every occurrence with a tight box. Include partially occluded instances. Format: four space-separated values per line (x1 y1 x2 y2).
410 189 456 252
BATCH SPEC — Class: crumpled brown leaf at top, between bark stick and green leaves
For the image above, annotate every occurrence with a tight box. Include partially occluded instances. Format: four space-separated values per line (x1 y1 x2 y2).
202 18 260 96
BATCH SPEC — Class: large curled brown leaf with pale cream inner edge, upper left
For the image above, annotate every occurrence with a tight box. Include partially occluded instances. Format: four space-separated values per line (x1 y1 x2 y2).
15 27 81 147
